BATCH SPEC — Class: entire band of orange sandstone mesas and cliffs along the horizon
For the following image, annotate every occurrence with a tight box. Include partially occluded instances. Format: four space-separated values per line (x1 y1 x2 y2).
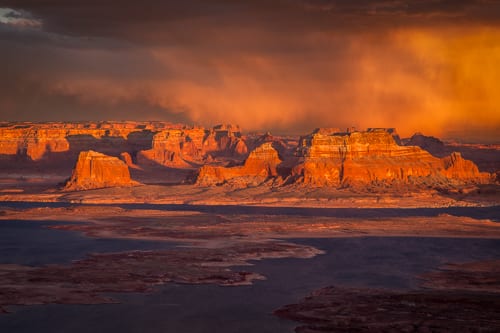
0 122 494 190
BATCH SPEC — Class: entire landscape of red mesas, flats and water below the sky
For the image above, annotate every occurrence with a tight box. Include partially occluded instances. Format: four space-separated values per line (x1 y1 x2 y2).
0 122 500 332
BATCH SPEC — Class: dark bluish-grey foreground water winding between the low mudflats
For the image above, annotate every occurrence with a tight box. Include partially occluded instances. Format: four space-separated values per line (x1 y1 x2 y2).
0 221 500 333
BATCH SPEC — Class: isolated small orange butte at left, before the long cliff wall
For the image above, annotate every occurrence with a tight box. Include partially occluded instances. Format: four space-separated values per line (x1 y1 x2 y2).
64 150 139 191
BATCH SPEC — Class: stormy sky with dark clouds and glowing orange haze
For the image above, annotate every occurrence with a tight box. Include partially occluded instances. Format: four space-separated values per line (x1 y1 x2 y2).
0 0 500 142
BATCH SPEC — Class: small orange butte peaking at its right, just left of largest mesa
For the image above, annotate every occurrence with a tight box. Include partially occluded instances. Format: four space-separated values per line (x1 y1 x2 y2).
196 142 281 186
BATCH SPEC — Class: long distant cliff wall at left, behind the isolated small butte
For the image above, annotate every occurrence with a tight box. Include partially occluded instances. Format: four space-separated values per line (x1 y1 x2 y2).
0 122 248 168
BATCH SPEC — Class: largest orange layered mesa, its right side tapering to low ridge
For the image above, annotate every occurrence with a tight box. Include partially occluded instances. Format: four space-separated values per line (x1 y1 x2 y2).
292 129 490 186
